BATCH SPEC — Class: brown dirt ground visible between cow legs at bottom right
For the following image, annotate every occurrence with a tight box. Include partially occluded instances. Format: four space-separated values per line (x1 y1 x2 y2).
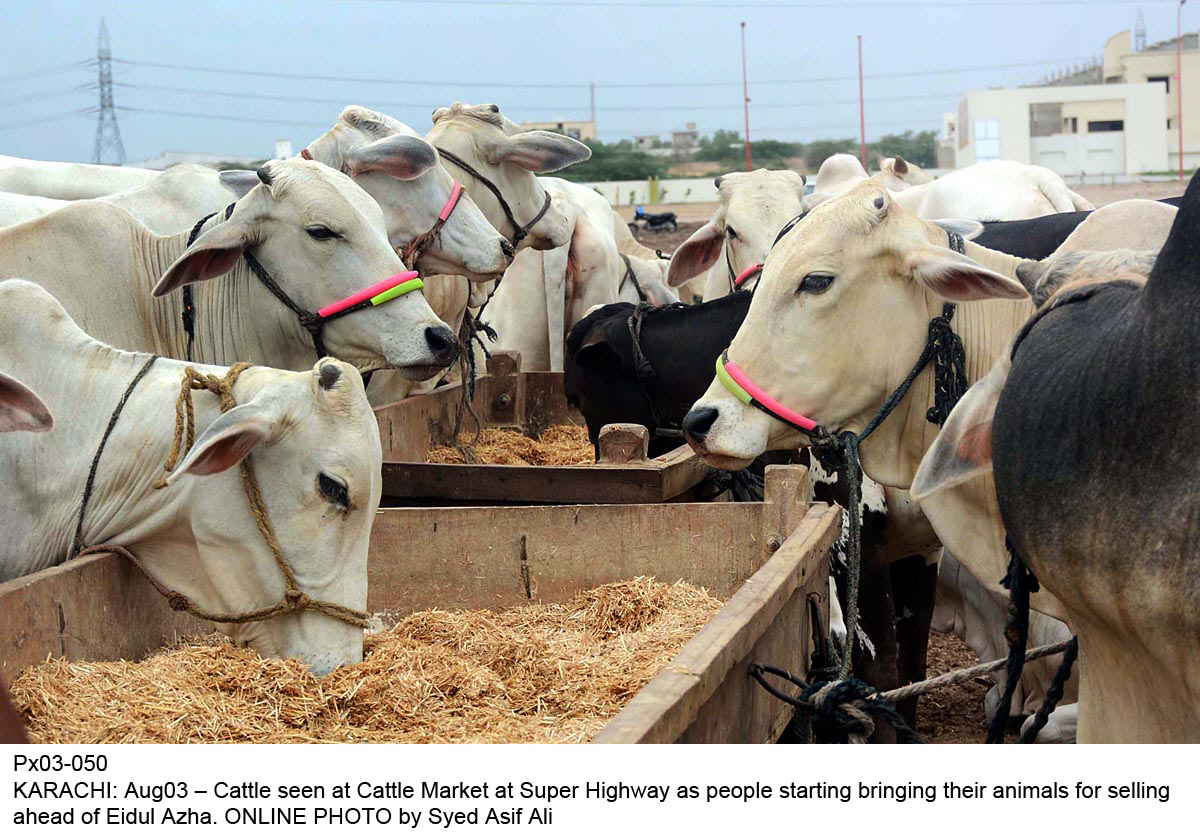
917 633 991 743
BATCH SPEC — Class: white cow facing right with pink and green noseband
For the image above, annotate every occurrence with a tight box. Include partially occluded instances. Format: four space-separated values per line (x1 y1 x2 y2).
0 159 456 378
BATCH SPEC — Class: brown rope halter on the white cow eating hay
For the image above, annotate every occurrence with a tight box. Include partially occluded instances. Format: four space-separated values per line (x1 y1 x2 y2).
84 363 367 627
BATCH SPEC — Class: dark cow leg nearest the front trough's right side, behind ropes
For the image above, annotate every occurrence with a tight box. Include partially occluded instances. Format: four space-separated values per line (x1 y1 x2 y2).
846 526 899 743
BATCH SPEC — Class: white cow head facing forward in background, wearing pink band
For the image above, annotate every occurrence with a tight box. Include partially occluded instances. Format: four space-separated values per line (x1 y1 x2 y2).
667 169 804 293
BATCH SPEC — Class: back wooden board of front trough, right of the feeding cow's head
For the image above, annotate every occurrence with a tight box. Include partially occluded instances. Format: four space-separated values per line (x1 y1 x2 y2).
367 502 764 615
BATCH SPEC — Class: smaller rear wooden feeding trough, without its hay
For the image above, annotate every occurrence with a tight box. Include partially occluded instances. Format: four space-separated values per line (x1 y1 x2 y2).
376 353 710 506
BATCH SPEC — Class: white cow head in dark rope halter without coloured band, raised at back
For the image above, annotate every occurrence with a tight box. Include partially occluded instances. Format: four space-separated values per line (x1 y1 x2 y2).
426 102 592 249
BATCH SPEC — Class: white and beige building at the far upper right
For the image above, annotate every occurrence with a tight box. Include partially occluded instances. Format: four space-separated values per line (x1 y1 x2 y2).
947 30 1200 177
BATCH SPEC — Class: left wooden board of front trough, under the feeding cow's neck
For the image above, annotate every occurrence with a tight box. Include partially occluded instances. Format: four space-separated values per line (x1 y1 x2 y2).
0 553 212 680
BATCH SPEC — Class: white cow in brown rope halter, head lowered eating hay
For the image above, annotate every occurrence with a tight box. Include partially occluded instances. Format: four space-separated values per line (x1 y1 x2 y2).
0 279 383 674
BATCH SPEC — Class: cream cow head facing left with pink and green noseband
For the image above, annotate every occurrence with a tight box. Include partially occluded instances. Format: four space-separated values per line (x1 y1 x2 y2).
684 182 1025 469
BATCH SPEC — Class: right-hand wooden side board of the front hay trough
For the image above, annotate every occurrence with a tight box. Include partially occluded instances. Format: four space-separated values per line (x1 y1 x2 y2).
593 505 841 743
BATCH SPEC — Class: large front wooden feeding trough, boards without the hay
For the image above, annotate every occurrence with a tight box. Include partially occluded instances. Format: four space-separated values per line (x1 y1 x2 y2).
0 465 841 742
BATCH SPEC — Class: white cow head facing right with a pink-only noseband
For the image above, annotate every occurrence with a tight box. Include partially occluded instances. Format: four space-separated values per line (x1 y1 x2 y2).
297 106 512 282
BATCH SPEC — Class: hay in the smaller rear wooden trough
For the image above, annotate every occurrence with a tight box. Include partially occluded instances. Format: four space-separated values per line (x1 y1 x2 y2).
425 424 595 465
